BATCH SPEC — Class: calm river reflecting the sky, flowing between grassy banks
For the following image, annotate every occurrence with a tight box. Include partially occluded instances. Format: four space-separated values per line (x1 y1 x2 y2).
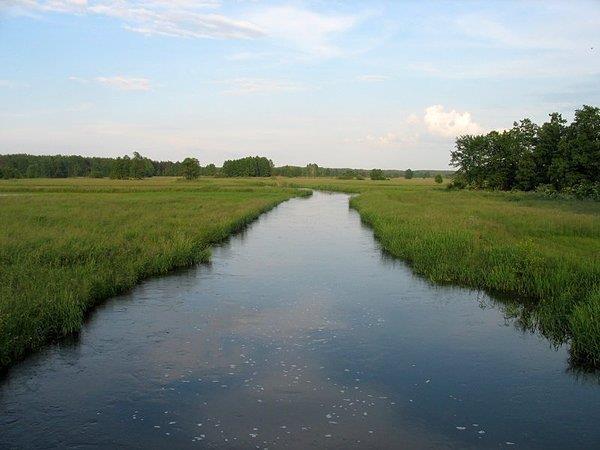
0 193 600 449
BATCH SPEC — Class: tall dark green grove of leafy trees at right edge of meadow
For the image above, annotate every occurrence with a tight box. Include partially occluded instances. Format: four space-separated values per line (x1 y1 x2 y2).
450 105 600 200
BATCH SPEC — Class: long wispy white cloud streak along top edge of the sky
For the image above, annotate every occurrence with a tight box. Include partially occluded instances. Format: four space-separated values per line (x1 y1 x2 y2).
8 0 357 53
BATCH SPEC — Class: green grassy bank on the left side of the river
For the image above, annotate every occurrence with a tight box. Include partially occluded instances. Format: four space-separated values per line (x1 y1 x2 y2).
0 179 303 367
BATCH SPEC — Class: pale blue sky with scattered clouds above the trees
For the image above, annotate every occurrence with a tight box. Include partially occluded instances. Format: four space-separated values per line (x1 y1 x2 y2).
0 0 600 169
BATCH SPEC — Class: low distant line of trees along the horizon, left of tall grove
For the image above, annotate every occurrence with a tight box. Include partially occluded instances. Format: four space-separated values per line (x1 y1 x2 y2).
0 152 453 179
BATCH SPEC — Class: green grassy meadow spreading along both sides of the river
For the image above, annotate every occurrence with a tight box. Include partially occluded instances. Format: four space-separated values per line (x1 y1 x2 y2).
0 178 600 367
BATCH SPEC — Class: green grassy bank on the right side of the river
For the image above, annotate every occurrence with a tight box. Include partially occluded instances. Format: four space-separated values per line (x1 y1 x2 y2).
293 179 600 367
